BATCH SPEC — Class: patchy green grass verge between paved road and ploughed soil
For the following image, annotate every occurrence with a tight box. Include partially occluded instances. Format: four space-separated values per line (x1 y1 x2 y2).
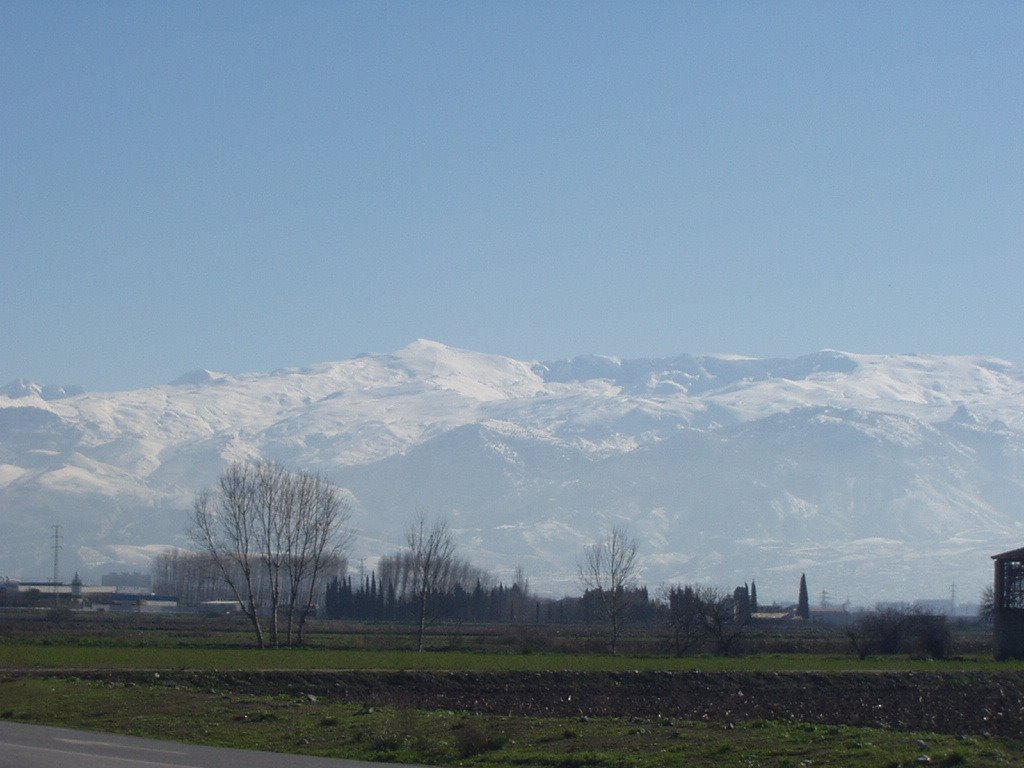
0 679 1007 768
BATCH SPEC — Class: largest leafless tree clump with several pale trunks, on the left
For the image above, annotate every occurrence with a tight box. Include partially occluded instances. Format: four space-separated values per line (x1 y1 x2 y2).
191 462 349 648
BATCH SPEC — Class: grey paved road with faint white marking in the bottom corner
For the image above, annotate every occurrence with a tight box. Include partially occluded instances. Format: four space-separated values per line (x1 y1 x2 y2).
0 721 436 768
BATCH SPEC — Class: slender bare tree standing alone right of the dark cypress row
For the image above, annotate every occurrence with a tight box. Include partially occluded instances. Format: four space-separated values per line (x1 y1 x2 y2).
580 525 640 654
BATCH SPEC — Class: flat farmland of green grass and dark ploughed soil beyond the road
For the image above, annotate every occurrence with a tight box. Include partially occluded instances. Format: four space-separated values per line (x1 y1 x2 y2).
0 614 1024 766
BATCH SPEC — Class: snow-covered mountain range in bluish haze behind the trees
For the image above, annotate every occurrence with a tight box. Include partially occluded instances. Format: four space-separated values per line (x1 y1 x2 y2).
0 340 1024 603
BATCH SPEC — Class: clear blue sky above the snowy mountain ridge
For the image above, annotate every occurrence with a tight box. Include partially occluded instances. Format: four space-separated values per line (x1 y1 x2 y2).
0 0 1024 390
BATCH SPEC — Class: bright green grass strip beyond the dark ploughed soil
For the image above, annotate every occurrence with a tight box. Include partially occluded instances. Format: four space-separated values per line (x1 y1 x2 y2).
0 642 1024 672
